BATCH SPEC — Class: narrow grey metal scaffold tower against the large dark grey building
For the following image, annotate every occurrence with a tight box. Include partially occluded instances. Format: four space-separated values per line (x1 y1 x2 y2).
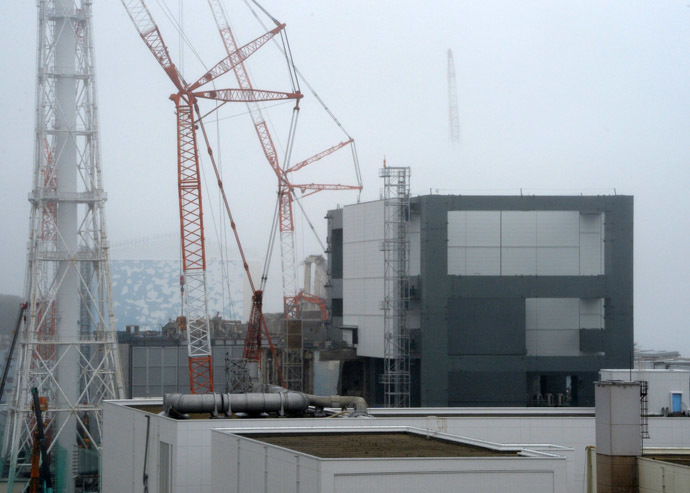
379 163 410 407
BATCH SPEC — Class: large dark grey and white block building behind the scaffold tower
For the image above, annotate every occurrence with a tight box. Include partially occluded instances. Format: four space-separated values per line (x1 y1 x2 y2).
327 195 633 406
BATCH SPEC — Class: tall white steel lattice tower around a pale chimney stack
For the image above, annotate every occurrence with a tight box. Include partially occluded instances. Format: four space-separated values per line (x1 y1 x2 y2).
3 0 124 492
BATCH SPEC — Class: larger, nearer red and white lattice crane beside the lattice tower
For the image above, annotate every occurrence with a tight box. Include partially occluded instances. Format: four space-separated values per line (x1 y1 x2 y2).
121 0 302 393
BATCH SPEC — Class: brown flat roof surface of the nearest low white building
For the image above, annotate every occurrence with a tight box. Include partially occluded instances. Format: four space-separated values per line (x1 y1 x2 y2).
236 431 518 459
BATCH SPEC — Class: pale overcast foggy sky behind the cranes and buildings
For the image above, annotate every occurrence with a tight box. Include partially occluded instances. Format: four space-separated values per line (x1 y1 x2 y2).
0 0 690 356
